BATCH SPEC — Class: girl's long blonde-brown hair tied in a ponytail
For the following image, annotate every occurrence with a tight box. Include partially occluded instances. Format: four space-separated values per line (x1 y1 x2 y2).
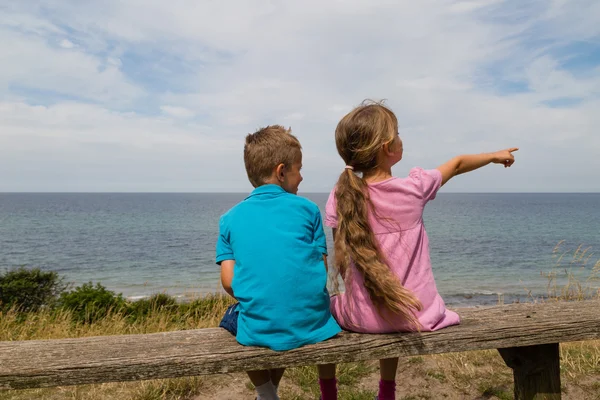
334 102 422 329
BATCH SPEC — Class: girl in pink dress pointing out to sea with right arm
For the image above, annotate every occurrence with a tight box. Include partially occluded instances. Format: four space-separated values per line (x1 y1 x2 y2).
325 103 518 400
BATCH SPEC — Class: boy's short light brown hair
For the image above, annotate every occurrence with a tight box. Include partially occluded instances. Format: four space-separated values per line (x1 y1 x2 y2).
244 125 302 187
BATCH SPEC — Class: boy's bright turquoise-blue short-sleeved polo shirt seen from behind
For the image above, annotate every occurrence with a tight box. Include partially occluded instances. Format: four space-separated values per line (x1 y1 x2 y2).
217 185 341 351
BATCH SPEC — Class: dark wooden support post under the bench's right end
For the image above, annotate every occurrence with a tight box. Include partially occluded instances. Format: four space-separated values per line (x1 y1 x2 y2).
498 343 561 400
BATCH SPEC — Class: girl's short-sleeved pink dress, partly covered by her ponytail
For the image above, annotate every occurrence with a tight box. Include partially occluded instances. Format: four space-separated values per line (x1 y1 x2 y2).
325 168 460 333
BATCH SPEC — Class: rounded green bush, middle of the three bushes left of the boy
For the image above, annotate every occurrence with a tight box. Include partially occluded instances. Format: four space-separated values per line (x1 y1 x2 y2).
58 282 126 323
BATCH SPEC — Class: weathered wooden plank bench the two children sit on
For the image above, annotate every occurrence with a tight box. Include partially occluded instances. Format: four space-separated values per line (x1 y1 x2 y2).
0 300 600 399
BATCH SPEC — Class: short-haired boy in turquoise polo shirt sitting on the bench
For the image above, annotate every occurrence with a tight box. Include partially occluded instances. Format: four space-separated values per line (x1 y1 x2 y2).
217 125 341 400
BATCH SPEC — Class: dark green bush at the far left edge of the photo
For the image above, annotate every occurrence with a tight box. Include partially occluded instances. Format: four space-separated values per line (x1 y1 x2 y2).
0 267 67 312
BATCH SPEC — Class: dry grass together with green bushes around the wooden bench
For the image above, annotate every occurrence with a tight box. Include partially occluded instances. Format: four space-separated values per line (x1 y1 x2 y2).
0 242 600 400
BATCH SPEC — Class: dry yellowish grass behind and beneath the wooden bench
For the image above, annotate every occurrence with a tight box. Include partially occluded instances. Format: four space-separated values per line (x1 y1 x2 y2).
0 242 600 400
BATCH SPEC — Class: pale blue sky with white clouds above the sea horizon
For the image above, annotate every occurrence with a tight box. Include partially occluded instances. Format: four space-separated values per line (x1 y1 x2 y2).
0 0 600 192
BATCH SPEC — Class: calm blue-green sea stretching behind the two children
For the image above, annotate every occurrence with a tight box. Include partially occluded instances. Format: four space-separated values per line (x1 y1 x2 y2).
0 193 600 305
